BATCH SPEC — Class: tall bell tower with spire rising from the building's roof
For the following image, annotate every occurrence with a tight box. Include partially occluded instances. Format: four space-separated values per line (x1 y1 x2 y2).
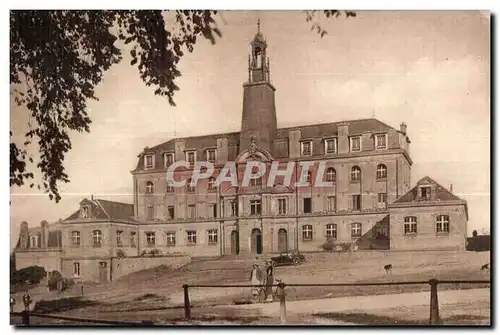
240 20 277 155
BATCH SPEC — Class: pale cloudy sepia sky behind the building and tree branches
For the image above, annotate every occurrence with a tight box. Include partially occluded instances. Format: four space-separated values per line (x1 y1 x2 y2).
10 11 490 248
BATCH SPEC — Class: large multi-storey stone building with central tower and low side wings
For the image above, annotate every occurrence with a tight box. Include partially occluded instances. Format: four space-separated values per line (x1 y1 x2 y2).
13 25 467 280
